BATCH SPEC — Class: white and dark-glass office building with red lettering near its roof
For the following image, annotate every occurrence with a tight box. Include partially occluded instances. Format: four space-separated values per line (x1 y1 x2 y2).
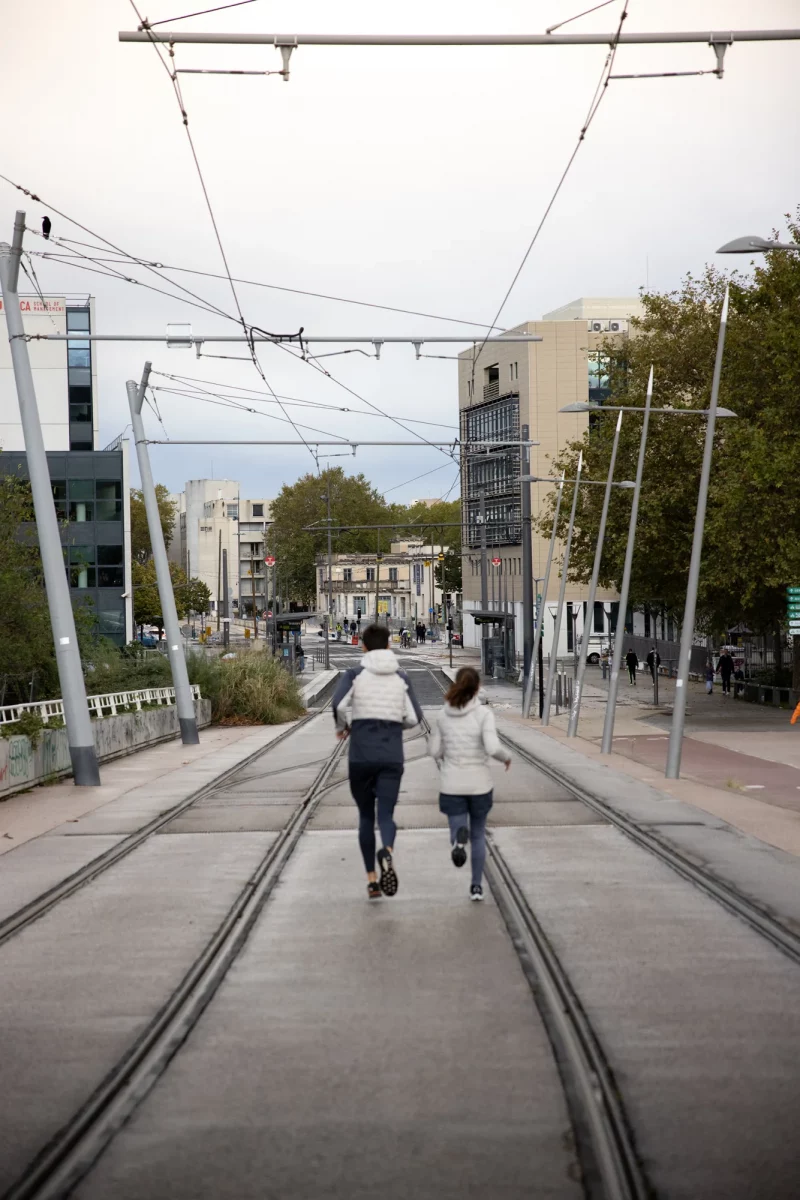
0 295 133 646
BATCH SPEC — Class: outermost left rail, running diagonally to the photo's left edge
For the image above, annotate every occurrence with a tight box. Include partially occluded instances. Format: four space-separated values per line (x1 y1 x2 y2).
0 709 321 946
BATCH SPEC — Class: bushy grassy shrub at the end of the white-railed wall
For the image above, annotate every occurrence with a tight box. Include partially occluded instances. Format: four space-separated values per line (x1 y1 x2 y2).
188 650 305 725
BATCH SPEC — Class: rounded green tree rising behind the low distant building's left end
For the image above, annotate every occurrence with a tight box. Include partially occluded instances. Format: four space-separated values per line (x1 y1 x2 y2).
266 467 407 607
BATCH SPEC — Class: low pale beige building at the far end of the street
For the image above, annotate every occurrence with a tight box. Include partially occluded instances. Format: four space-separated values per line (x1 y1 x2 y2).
317 541 455 629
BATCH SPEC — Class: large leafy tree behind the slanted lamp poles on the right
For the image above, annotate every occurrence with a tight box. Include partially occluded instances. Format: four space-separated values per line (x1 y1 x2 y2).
540 210 800 682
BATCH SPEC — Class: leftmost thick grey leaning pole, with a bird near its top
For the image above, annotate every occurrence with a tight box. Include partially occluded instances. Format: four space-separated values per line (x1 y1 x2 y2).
0 211 100 787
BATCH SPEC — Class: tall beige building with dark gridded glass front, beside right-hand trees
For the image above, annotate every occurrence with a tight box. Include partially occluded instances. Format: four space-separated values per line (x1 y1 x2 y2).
458 298 642 654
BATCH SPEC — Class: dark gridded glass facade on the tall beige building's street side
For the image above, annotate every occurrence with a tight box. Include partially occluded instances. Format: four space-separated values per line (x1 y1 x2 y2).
461 391 522 547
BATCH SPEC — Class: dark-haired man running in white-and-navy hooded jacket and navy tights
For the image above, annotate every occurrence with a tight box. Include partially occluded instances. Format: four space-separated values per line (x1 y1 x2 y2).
332 625 422 900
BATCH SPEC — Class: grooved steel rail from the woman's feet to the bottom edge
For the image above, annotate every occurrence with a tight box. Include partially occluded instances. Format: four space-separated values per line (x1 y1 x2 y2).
422 668 652 1200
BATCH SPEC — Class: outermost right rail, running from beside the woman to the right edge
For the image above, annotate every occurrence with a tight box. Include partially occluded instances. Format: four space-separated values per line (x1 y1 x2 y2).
499 733 800 964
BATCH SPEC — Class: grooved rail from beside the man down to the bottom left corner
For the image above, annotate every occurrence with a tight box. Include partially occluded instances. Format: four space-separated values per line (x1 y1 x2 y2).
2 713 344 1200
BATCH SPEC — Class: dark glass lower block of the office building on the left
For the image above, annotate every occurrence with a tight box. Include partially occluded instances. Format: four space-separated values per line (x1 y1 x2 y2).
0 450 125 646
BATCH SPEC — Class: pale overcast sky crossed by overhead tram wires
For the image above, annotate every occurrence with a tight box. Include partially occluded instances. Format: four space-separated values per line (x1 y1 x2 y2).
0 0 800 500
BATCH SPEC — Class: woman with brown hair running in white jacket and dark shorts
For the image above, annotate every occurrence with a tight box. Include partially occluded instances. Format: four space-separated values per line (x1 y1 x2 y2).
428 667 511 900
